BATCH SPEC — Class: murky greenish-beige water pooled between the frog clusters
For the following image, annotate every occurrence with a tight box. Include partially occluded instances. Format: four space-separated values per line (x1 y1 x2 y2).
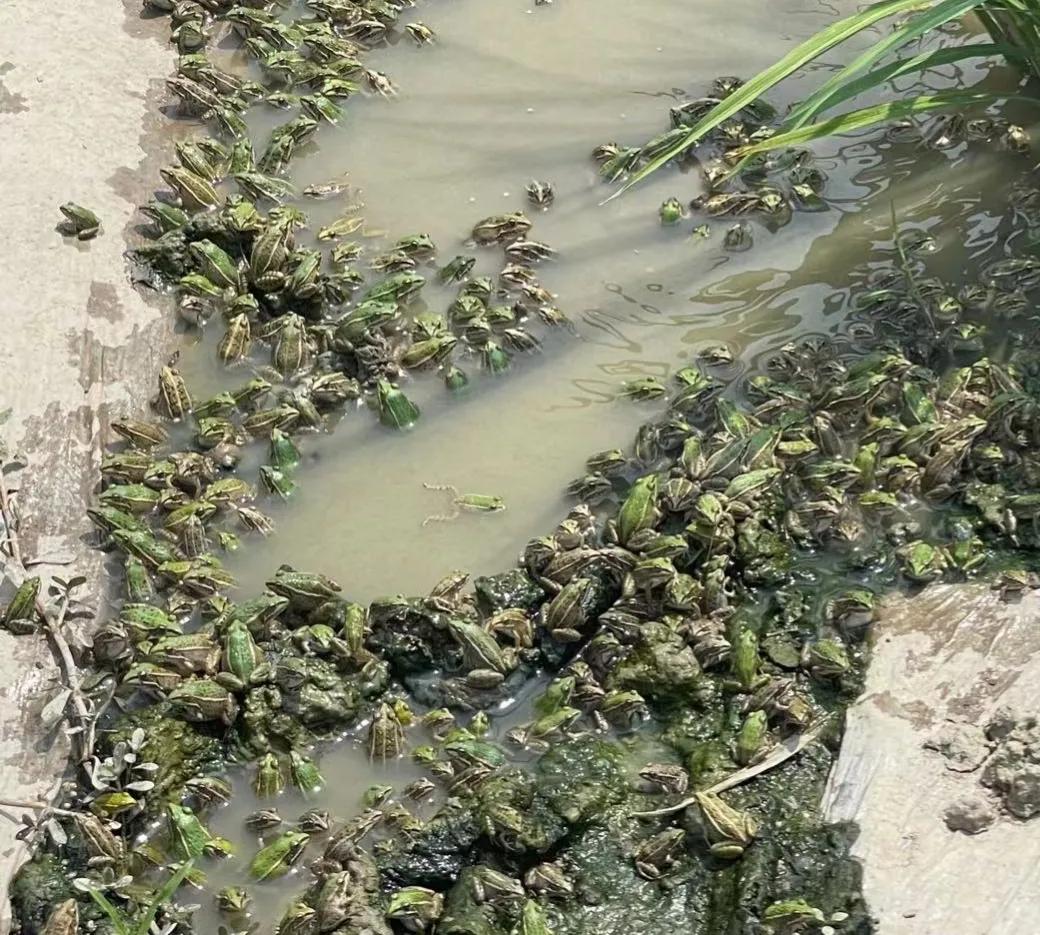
172 0 1040 932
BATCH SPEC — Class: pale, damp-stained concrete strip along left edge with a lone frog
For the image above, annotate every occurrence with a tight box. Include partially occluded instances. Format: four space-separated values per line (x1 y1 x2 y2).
0 0 176 935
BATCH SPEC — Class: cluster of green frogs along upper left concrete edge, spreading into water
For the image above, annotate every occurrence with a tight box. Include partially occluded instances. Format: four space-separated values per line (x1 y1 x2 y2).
119 0 567 441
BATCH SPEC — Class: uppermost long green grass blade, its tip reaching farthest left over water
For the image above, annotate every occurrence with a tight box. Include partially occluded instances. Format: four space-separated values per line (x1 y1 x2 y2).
606 0 931 201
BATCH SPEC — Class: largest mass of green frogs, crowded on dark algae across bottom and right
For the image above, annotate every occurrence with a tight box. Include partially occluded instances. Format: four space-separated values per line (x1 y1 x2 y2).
16 212 1040 935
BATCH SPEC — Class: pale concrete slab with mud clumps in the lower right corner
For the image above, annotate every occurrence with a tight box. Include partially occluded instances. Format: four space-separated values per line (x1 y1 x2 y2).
826 585 1040 935
